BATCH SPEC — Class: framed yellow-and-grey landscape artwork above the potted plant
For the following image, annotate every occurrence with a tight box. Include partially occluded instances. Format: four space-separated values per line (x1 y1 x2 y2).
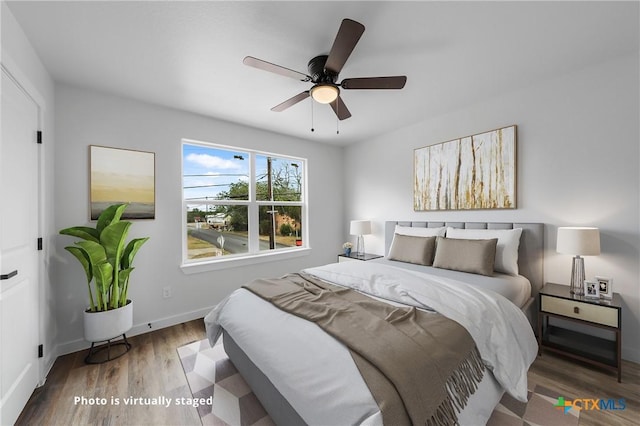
89 145 156 220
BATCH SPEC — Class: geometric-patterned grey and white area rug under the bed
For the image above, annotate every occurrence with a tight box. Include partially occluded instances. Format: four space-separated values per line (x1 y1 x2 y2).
178 339 580 426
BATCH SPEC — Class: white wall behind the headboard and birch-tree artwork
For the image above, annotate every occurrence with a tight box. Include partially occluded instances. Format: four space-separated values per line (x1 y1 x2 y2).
345 54 640 362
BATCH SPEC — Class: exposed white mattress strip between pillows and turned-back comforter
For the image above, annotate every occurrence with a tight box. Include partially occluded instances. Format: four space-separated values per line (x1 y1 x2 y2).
368 258 531 308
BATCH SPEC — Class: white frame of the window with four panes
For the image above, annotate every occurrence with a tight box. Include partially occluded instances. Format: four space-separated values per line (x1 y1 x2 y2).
180 138 311 273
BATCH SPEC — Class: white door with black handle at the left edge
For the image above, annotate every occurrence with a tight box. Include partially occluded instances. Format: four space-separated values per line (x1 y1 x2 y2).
0 69 40 426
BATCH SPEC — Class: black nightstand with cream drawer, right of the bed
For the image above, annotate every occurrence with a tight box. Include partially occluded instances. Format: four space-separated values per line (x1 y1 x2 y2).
538 283 622 382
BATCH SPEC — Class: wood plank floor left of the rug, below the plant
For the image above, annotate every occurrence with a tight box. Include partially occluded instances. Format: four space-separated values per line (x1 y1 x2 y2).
16 320 205 426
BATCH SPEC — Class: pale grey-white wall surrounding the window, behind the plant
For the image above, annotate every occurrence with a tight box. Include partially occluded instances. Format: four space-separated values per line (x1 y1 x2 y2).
51 85 344 353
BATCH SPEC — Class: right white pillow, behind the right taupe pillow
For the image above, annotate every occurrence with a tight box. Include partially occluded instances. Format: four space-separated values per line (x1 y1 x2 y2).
447 227 522 275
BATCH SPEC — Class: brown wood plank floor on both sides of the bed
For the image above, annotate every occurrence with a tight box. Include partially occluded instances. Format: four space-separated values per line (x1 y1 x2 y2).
16 320 640 426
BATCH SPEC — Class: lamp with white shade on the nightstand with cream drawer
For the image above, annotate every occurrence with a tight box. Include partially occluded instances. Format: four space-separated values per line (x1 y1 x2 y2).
556 226 600 296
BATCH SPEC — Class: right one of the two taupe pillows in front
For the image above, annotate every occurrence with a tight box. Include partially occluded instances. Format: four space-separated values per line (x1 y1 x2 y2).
433 237 498 276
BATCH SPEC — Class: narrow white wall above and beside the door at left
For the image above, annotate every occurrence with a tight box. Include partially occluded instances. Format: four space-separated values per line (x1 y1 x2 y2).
0 2 57 378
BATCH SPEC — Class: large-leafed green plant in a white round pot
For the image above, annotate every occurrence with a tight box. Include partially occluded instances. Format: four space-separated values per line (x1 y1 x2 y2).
60 204 149 348
